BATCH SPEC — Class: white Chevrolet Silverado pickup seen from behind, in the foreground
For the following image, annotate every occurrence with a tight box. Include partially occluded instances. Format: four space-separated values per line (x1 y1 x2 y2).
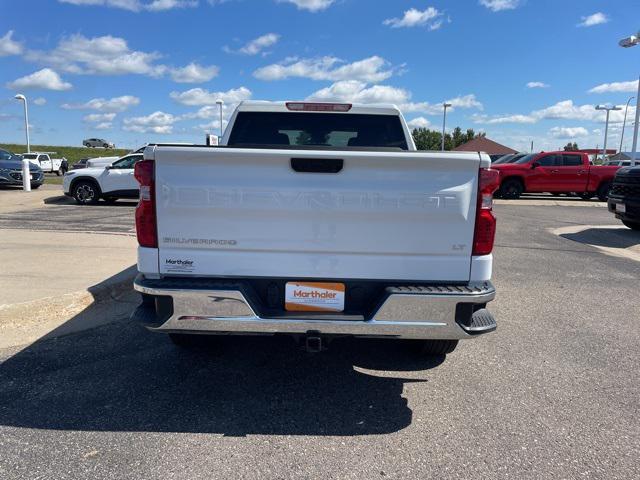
132 102 498 355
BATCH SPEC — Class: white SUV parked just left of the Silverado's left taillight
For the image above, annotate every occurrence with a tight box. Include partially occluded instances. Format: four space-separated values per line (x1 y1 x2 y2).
62 154 142 205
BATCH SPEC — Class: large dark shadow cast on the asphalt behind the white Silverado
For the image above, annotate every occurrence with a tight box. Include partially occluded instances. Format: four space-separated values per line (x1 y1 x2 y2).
0 268 444 436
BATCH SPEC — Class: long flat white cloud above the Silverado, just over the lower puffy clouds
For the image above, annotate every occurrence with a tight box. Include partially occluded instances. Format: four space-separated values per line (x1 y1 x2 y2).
253 56 393 83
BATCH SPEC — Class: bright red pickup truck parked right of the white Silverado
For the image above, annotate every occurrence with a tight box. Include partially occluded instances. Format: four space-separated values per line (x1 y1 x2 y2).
491 151 620 202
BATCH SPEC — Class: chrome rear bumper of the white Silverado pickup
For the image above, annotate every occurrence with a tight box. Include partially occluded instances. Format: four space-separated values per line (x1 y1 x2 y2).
133 275 496 340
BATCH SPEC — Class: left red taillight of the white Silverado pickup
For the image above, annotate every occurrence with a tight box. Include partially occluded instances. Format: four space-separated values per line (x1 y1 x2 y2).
134 160 158 248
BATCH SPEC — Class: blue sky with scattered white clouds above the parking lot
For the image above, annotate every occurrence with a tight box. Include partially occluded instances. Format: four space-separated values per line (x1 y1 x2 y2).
0 0 640 150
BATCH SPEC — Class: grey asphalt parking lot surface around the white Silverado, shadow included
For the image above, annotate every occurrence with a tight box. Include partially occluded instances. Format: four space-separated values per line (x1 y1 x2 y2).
0 194 640 479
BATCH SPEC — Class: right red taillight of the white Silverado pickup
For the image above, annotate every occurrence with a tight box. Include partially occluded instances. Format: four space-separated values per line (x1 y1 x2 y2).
472 168 500 255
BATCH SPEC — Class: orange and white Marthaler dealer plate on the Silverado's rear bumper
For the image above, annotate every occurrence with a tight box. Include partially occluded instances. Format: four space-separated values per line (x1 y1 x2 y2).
284 282 345 312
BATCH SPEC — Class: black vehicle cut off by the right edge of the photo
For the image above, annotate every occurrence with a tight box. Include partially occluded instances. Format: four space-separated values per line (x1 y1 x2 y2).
608 165 640 230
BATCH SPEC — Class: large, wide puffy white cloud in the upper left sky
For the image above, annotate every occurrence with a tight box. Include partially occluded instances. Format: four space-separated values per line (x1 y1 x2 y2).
26 34 167 76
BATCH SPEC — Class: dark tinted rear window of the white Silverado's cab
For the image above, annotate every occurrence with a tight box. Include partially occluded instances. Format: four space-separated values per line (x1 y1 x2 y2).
228 112 408 150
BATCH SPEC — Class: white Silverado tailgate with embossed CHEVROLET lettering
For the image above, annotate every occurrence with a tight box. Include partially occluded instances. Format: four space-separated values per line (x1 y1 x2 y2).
154 146 480 282
